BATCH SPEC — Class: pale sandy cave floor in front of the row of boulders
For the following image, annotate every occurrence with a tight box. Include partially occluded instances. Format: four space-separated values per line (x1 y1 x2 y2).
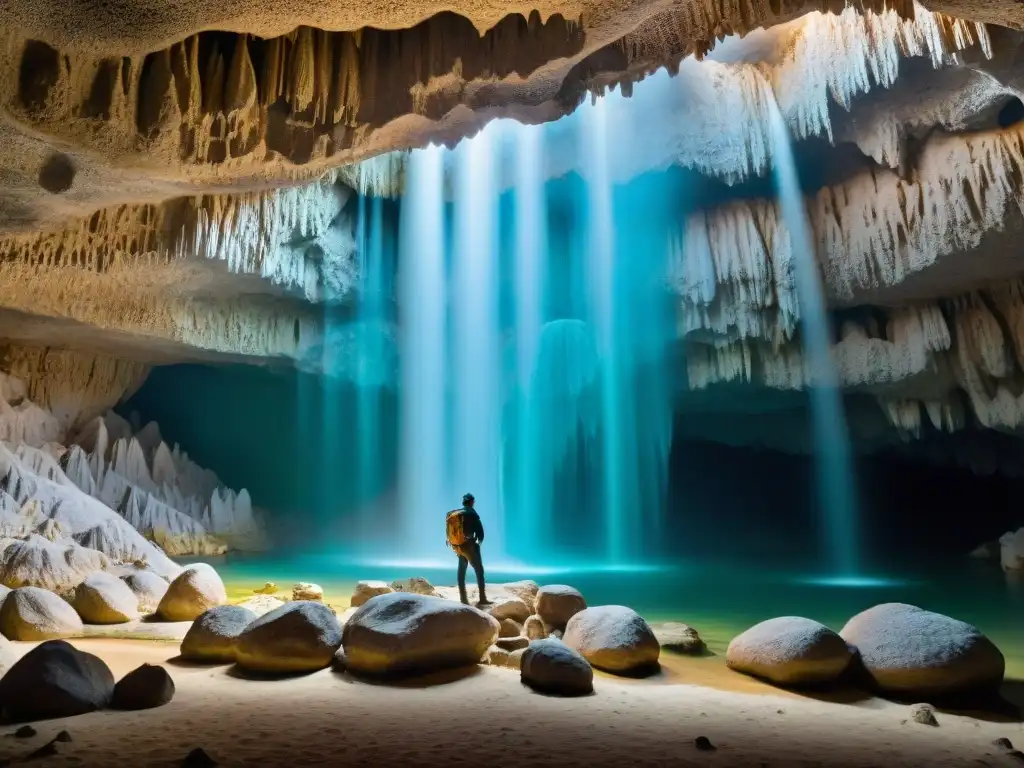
0 639 1024 768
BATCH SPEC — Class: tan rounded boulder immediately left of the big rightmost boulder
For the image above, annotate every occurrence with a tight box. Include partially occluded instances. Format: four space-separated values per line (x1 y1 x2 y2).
725 616 853 686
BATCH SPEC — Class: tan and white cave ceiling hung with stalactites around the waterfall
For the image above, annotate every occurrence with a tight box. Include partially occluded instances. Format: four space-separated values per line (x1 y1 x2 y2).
0 0 1024 468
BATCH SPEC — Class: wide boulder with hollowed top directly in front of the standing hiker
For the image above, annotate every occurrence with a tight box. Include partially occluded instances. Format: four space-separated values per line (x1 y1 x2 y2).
342 592 498 675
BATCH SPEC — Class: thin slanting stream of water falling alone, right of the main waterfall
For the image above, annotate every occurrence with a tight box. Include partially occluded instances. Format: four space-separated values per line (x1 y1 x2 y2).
765 89 860 580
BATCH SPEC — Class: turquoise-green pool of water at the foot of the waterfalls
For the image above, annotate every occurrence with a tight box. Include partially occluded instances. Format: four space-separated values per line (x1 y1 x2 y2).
186 554 1024 680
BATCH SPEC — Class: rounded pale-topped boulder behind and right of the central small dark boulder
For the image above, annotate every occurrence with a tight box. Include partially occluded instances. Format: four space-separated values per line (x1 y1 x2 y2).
562 605 662 673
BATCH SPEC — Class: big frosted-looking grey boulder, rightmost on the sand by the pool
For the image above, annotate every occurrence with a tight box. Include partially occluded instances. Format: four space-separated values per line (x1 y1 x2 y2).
840 603 1006 698
